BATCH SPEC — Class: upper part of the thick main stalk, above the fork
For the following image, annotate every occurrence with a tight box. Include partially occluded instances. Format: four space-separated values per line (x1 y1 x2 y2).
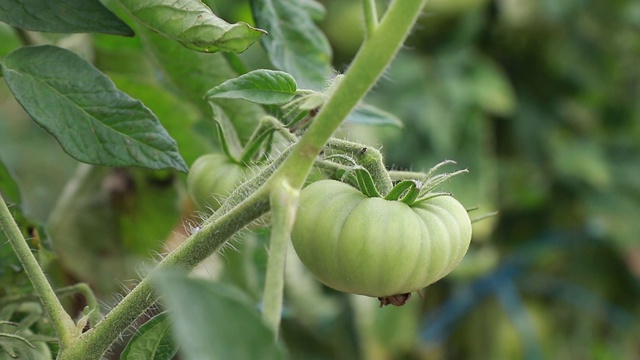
272 0 426 188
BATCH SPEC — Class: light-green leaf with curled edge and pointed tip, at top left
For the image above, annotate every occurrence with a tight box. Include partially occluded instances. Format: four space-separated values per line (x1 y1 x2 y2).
119 0 265 53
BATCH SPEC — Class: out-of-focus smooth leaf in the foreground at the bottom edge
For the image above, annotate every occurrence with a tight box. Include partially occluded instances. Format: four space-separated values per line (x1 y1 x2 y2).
155 272 284 360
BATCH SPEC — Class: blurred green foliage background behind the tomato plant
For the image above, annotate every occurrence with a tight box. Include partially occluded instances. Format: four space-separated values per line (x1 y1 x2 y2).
0 0 640 359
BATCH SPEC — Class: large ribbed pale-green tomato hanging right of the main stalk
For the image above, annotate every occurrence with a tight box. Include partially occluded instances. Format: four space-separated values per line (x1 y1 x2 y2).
291 180 471 305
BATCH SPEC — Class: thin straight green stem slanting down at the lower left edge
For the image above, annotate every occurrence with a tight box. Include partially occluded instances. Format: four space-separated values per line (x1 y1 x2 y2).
0 196 76 349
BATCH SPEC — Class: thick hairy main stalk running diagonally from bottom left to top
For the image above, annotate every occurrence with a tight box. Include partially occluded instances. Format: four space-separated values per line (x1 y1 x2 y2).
59 0 426 359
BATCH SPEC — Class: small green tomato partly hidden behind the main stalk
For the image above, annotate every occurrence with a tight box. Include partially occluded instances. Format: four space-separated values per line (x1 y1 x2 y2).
187 154 248 211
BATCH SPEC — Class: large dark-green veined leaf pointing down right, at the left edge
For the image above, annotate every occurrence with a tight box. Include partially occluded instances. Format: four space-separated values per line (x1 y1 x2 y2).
2 45 187 172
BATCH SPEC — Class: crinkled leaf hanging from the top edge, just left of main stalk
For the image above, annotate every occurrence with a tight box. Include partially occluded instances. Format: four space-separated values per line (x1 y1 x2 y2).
251 0 331 90
